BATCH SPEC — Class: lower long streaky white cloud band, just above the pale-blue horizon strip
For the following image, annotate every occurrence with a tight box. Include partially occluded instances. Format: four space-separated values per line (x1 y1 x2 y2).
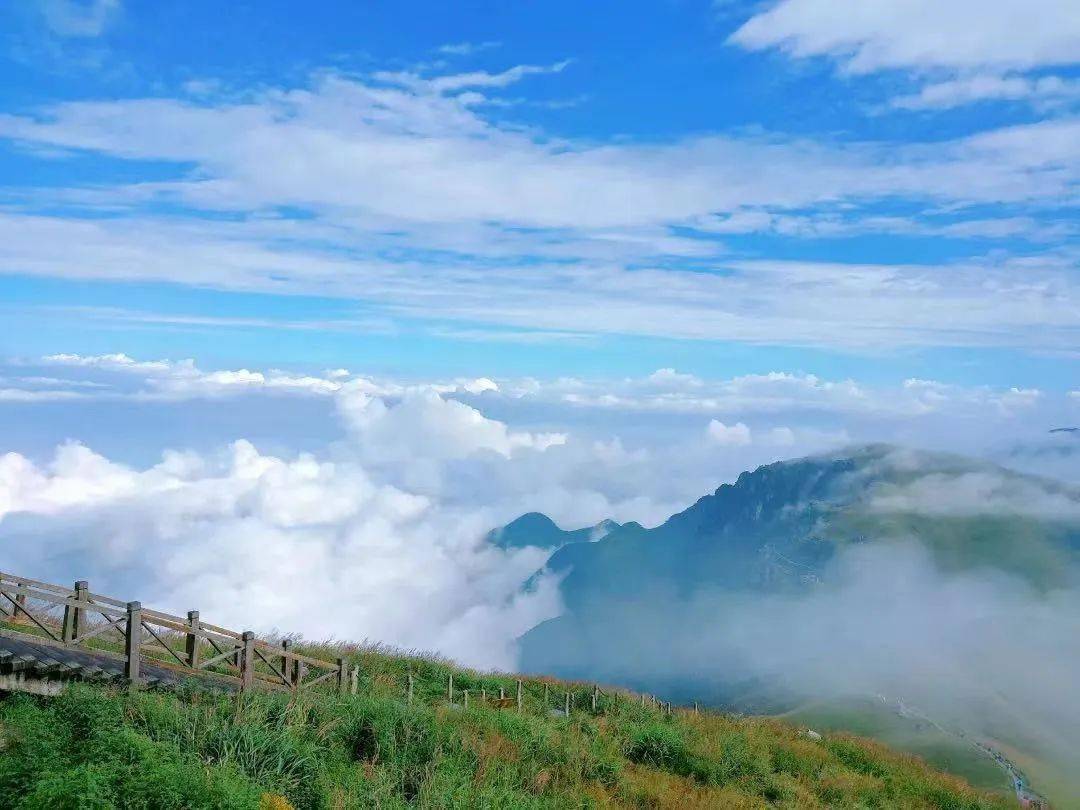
14 209 1080 350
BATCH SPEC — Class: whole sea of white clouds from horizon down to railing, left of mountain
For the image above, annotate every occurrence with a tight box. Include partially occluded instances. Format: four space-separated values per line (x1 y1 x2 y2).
0 354 1076 669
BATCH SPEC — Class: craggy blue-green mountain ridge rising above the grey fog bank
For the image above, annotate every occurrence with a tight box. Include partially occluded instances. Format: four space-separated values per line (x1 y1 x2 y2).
511 445 1080 626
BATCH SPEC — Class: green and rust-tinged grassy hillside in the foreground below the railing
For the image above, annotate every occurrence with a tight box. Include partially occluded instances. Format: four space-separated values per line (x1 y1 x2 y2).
0 650 1013 810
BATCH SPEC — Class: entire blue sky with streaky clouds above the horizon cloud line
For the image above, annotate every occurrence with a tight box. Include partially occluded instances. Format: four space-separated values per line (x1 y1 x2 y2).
0 0 1080 393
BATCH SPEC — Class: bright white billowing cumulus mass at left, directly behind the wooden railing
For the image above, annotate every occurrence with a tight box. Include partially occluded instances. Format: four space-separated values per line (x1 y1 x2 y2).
0 403 574 667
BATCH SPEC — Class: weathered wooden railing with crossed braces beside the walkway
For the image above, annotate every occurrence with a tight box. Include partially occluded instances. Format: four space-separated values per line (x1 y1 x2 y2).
0 572 356 691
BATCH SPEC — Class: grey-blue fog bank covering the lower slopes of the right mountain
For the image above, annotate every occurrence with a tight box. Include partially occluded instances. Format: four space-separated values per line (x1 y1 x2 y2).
540 539 1080 794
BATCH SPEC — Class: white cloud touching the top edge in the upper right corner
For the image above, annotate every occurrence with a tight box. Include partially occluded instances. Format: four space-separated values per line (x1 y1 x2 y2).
730 0 1080 73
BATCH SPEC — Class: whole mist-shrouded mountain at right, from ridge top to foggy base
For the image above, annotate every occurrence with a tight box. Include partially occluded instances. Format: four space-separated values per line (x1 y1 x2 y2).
505 445 1080 803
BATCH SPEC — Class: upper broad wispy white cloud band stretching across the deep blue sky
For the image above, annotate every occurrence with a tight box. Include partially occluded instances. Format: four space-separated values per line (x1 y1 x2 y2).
0 75 1076 231
